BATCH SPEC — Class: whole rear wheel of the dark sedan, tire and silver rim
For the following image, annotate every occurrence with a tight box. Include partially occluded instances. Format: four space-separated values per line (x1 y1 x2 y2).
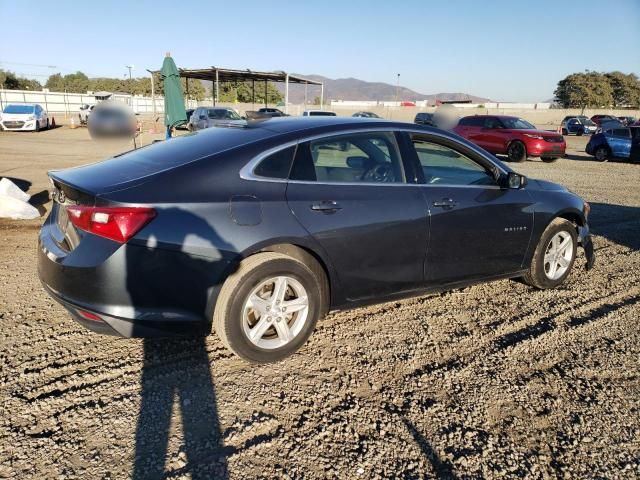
213 252 327 363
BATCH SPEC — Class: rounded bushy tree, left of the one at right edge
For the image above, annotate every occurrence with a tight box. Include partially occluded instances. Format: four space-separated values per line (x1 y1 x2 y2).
554 71 614 109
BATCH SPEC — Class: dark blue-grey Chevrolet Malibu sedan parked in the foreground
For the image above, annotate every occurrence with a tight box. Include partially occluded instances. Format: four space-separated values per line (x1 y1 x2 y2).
38 117 594 363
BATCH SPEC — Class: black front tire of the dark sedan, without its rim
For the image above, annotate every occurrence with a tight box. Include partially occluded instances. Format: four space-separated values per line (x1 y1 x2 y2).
523 218 578 290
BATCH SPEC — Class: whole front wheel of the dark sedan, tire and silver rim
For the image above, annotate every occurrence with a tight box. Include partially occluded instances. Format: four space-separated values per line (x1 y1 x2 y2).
524 218 578 289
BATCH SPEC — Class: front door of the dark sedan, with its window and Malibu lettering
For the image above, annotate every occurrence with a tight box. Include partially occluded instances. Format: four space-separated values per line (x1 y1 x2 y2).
407 133 533 285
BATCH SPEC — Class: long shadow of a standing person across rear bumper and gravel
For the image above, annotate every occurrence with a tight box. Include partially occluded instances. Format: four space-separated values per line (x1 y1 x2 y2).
126 208 237 480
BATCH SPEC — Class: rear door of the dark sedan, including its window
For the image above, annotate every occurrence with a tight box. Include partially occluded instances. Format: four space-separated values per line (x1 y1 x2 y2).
286 131 428 301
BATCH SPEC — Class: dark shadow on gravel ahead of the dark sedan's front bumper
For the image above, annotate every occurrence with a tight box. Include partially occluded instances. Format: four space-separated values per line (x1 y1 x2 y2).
589 203 640 250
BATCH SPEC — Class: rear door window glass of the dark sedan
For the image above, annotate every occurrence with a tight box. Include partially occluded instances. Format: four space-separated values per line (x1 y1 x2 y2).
290 132 404 183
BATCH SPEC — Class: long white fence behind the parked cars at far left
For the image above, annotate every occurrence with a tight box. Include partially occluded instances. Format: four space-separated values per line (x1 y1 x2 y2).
0 90 198 115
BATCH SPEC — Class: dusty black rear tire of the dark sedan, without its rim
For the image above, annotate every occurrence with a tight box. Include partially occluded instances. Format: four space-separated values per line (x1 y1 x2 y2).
213 252 328 363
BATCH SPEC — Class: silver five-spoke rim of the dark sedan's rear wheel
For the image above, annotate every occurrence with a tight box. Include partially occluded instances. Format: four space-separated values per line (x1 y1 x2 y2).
242 276 309 350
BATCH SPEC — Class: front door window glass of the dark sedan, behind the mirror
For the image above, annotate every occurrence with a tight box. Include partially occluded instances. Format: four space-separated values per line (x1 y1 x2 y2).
411 135 497 185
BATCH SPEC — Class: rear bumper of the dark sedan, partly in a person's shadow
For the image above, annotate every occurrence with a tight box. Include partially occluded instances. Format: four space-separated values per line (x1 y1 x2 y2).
38 214 223 337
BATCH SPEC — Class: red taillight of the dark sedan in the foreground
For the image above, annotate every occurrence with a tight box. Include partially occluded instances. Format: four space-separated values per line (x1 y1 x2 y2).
67 206 156 243
